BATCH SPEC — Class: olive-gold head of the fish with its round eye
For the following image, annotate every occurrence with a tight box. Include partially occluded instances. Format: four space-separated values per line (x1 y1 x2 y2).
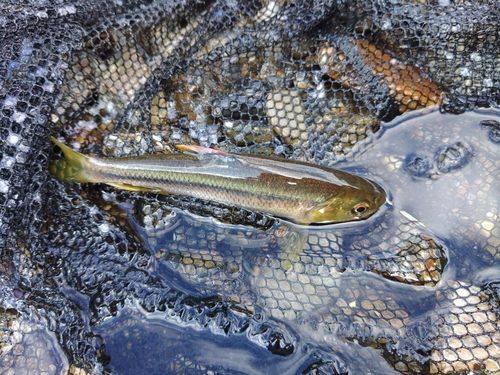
300 180 387 224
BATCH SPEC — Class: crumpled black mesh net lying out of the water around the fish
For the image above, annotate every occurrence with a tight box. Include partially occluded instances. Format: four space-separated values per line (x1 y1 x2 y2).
0 0 500 373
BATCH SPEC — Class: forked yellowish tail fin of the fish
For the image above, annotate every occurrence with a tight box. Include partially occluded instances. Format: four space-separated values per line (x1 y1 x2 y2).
49 137 92 182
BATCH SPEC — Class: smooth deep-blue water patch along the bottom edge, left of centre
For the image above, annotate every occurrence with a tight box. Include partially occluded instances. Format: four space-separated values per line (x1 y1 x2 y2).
96 305 311 374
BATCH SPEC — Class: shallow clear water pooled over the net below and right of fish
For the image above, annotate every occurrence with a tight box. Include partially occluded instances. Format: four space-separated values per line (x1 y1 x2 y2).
94 110 500 374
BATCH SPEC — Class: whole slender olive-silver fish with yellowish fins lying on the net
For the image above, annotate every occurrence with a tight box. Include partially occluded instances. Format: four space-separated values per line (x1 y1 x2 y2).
49 137 387 225
